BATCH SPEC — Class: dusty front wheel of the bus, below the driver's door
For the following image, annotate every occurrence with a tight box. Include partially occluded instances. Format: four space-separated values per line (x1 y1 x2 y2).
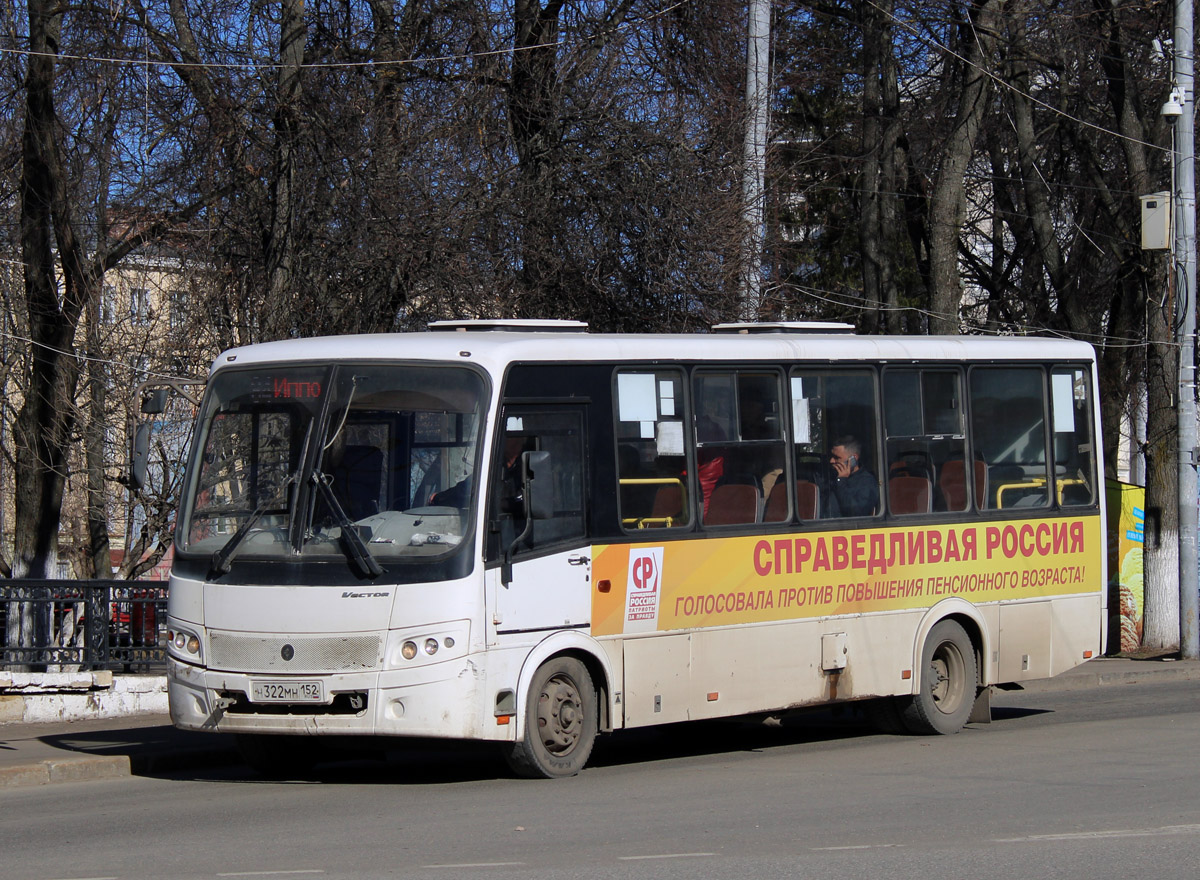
504 657 598 779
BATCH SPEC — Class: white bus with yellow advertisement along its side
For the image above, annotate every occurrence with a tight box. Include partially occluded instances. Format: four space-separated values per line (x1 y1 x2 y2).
169 322 1106 777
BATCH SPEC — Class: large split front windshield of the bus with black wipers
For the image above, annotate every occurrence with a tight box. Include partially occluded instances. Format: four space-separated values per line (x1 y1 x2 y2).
180 364 485 576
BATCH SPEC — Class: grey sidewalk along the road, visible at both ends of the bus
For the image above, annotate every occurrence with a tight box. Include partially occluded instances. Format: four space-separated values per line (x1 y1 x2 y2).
0 657 1200 789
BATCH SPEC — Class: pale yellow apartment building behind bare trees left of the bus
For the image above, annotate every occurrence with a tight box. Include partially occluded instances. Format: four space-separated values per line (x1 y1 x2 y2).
0 247 216 577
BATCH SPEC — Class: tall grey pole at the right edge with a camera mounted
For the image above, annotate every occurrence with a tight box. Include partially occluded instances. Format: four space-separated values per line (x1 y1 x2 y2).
1164 0 1200 660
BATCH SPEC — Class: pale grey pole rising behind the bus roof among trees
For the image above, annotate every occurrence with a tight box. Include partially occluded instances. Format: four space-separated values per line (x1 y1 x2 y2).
739 0 770 321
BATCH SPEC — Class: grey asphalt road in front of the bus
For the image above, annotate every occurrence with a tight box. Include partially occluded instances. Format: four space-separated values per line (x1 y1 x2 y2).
0 682 1200 880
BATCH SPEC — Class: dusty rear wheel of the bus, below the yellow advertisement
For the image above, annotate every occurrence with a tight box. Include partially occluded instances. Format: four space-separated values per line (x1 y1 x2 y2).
904 619 979 734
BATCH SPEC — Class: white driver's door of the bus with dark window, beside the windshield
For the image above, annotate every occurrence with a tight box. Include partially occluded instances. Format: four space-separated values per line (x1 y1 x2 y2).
487 403 592 636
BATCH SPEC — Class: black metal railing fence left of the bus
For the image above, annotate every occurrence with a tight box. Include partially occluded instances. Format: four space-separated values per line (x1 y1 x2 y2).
0 577 167 672
